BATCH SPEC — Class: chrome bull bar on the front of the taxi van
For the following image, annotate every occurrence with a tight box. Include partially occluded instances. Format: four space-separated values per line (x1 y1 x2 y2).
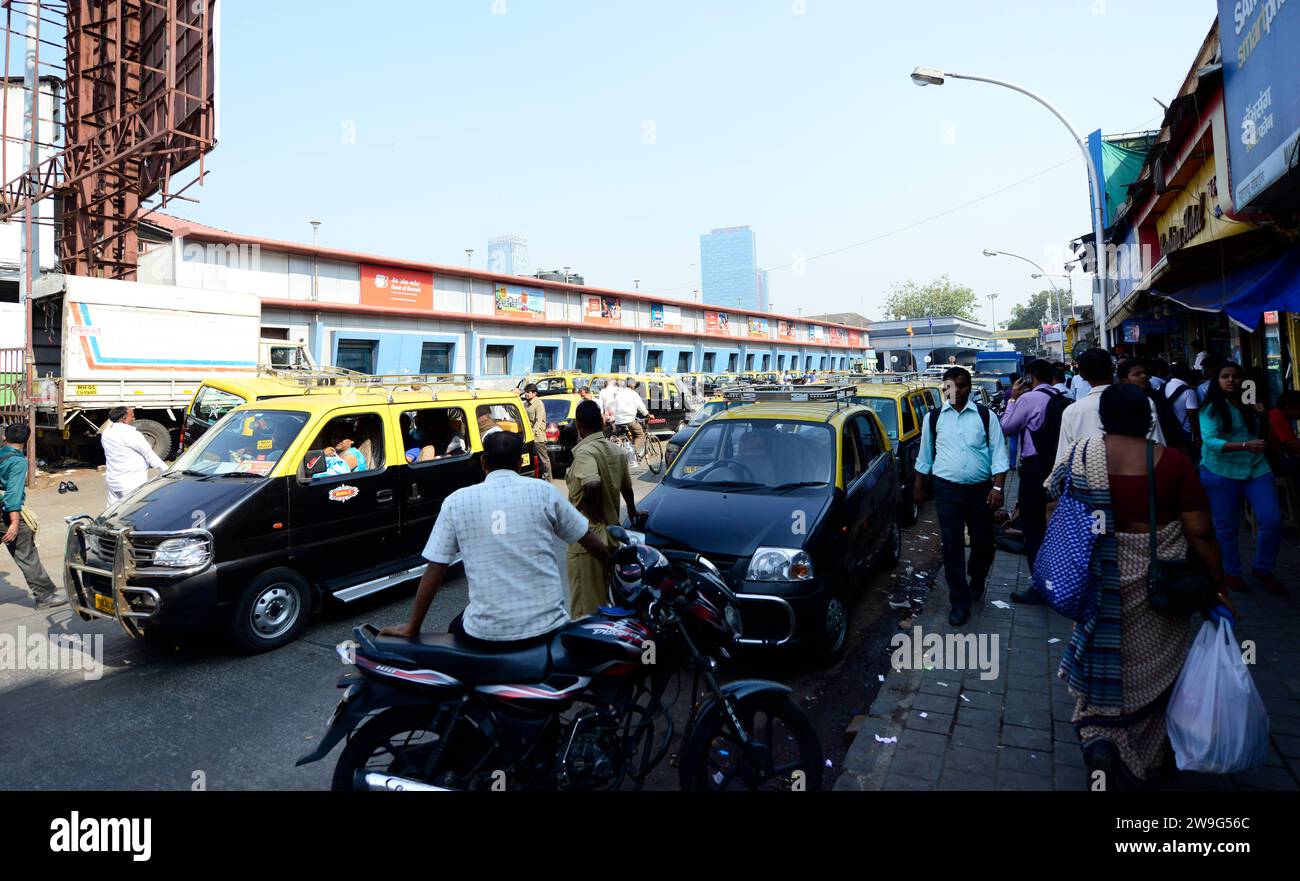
64 515 212 638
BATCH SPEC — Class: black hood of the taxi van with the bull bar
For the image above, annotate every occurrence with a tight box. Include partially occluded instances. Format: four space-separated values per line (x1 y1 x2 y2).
95 474 269 531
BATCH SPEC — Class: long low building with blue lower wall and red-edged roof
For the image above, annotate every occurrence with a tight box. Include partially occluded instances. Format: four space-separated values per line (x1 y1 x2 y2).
140 216 867 381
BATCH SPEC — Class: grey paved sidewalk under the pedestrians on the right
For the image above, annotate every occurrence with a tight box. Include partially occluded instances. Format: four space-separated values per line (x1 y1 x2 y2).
835 480 1300 790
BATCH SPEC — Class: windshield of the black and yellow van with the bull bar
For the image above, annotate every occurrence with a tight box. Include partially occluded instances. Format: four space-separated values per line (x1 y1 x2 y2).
172 409 307 477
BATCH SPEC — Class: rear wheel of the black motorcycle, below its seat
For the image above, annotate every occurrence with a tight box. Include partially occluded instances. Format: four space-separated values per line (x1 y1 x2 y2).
330 707 488 791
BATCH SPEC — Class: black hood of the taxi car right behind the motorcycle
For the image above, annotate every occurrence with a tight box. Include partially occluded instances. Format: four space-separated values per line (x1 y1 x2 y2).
637 483 833 556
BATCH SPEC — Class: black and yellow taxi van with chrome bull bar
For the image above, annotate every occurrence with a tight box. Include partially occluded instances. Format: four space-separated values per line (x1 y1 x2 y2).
64 378 537 651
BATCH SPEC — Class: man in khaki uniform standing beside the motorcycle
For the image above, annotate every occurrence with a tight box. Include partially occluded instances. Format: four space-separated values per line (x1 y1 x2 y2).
564 400 637 619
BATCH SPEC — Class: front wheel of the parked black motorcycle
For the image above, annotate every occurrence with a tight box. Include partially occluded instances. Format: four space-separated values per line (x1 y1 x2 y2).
681 693 823 791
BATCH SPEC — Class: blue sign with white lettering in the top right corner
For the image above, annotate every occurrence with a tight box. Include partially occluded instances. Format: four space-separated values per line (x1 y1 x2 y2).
1218 0 1300 211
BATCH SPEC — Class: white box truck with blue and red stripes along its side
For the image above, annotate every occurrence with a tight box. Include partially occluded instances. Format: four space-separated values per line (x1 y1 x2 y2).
33 275 271 460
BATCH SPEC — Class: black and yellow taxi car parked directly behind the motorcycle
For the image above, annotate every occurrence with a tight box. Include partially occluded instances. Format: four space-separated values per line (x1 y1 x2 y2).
631 386 902 661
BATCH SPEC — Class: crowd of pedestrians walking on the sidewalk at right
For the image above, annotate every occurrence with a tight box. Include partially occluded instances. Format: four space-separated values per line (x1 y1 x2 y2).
914 342 1300 786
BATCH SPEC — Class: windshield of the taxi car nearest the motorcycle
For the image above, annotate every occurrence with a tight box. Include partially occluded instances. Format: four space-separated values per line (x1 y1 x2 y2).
666 418 835 490
